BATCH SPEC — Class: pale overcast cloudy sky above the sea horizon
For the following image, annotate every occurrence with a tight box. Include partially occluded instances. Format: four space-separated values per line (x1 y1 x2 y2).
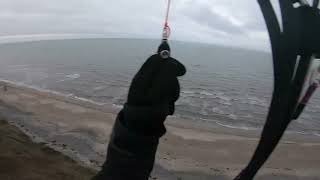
0 0 292 49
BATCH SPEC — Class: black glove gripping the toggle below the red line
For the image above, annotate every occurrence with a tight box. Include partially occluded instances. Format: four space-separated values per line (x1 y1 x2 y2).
121 51 186 137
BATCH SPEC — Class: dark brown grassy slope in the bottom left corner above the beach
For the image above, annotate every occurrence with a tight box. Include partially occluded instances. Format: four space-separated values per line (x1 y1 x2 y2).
0 120 95 180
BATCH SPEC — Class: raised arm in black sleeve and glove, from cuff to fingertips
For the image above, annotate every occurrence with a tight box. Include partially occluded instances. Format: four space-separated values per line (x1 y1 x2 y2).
93 54 186 180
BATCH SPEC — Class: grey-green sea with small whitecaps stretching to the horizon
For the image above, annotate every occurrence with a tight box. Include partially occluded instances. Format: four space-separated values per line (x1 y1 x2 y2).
0 39 320 136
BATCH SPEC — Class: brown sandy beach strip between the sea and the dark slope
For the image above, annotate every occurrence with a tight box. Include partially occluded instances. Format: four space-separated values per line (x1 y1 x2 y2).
0 82 320 180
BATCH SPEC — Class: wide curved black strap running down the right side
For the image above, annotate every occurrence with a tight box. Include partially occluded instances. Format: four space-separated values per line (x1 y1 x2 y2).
236 0 320 180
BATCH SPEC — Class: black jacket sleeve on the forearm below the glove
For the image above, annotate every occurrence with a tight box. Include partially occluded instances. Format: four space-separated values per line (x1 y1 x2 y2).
92 111 159 180
